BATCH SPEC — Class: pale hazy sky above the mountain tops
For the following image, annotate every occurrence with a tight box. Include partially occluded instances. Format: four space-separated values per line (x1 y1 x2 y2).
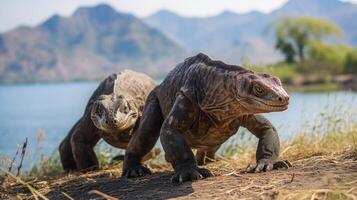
0 0 357 32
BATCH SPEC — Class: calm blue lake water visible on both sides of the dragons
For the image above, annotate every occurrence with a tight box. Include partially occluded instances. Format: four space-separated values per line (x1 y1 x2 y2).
0 82 357 170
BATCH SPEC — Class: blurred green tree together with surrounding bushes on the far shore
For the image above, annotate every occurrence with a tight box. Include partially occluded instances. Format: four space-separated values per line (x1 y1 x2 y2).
258 17 357 91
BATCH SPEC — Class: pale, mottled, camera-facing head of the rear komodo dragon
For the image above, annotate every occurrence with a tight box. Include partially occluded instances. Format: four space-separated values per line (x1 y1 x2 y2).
91 95 139 133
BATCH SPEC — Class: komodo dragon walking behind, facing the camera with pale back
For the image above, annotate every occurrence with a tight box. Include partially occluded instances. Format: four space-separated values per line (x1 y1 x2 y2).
59 70 155 172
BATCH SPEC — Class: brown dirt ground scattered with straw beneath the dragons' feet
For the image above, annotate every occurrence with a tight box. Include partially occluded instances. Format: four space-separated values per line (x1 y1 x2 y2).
0 153 357 199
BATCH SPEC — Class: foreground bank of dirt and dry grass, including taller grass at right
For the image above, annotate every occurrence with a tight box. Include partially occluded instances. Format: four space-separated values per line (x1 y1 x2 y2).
0 128 357 200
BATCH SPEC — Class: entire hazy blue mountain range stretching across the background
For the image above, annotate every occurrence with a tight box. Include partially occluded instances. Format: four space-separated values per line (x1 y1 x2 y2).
0 0 357 82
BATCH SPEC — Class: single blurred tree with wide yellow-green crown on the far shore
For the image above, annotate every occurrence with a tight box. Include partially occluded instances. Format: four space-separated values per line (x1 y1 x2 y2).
268 16 343 63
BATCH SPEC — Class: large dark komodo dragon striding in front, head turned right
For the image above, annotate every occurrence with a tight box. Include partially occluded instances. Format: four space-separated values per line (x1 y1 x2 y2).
123 53 289 182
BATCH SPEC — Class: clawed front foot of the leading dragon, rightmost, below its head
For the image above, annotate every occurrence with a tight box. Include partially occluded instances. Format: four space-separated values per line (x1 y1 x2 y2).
243 159 292 173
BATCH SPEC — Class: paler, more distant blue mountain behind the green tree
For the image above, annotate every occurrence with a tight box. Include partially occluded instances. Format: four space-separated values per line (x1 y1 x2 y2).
144 0 357 64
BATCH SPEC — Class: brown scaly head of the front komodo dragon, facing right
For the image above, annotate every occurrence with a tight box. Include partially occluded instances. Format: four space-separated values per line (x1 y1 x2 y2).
237 71 289 114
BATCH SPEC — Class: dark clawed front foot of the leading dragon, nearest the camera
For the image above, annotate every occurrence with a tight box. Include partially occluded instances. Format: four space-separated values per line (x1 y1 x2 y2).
171 167 212 183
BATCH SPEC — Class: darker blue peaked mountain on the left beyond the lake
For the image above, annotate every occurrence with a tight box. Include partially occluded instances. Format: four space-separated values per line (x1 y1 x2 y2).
0 4 184 82
